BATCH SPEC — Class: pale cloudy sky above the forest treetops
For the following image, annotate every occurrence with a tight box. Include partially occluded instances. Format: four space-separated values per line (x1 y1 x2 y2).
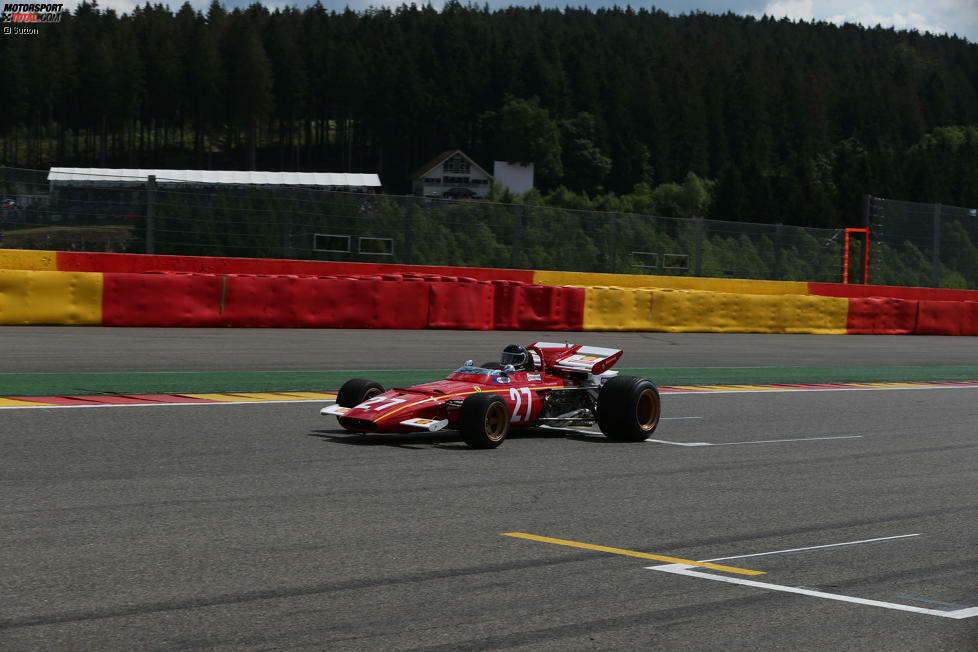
86 0 978 43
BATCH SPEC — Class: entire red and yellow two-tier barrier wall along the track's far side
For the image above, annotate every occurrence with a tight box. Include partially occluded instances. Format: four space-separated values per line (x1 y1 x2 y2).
0 250 978 335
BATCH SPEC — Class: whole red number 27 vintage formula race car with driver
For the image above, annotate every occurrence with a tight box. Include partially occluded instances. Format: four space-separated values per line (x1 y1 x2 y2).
320 342 660 448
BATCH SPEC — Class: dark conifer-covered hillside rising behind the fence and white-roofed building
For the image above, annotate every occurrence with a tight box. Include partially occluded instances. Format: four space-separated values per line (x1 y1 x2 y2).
0 3 978 227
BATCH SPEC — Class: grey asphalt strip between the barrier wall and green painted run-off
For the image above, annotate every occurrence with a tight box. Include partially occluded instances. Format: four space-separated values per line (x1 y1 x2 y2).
0 326 978 373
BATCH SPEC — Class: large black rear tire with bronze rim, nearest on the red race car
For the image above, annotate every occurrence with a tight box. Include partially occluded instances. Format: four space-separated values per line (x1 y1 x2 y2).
598 376 662 441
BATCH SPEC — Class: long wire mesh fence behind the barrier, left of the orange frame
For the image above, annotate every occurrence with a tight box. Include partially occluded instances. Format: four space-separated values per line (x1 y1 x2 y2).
0 168 842 282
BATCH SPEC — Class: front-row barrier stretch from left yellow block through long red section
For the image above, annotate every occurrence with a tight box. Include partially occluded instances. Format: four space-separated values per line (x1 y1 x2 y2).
0 270 585 331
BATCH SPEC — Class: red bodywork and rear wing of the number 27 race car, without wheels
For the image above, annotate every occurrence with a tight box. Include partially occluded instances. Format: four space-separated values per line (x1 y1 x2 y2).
339 345 622 433
